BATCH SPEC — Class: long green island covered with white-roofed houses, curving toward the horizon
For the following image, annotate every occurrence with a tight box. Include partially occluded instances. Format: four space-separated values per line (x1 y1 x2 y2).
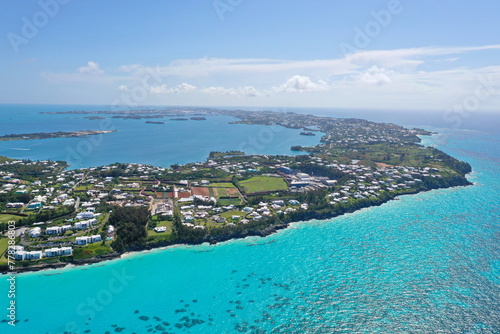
0 108 471 273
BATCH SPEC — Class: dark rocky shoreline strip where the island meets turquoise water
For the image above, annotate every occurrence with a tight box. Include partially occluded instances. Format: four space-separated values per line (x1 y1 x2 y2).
0 177 476 276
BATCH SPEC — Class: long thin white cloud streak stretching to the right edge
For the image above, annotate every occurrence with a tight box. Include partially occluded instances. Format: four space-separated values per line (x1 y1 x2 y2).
112 45 500 81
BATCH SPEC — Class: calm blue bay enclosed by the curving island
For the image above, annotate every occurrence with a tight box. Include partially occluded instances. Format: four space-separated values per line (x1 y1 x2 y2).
0 105 321 168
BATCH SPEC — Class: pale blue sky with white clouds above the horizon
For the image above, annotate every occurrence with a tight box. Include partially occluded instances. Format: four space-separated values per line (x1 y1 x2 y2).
0 0 500 112
